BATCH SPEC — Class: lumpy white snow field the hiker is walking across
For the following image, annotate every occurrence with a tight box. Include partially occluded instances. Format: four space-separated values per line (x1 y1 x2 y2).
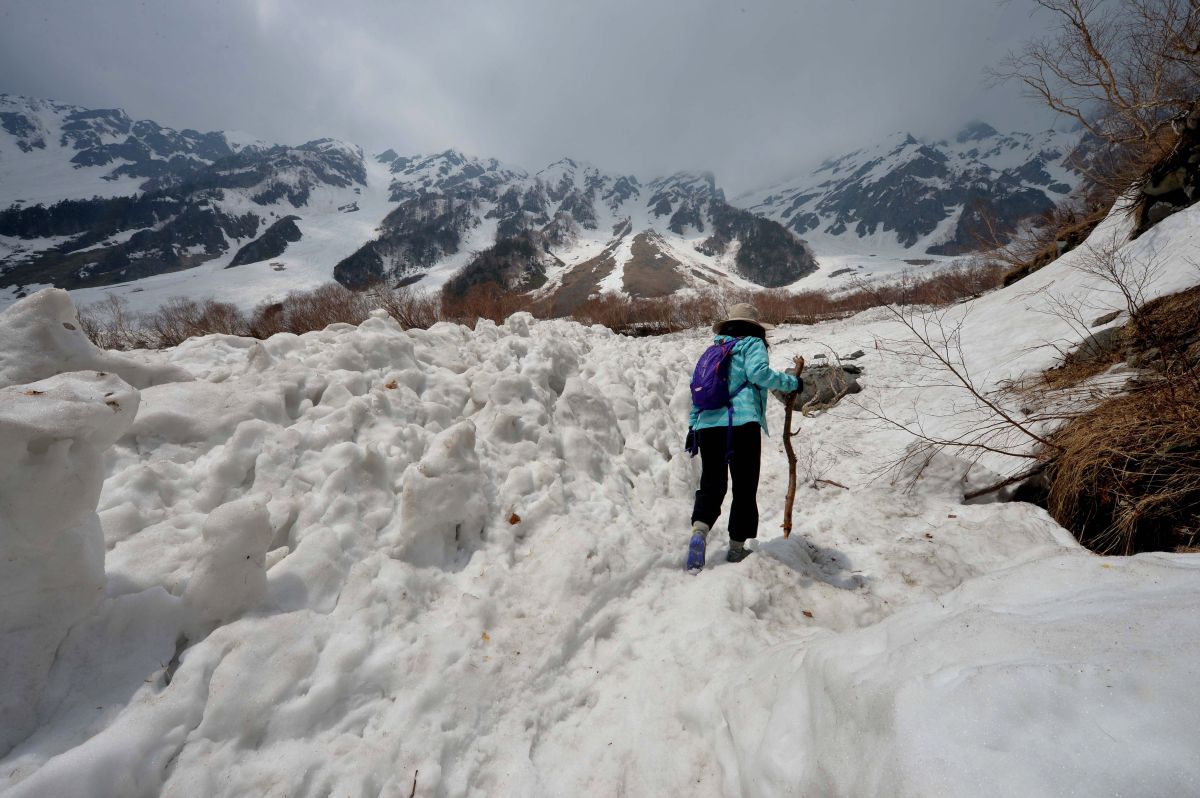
7 202 1200 798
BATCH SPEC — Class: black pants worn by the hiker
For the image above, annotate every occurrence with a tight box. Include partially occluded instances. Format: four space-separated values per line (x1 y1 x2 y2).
691 421 762 541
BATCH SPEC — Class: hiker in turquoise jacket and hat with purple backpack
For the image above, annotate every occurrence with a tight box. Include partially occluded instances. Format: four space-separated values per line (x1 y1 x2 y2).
688 302 804 571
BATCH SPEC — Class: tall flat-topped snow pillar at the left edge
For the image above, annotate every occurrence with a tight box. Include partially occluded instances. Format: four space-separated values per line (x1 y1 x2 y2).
0 369 138 754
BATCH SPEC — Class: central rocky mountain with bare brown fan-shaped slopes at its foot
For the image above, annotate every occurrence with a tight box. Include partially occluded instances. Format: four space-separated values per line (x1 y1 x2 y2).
335 151 816 312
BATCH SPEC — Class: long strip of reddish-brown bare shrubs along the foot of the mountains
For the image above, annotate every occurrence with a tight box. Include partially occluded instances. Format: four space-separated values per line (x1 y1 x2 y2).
79 260 1000 349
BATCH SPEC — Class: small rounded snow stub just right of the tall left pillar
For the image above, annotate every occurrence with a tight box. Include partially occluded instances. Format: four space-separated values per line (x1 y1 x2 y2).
184 499 272 638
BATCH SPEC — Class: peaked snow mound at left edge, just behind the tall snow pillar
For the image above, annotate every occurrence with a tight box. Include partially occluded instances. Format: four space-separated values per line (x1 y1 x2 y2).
0 288 191 388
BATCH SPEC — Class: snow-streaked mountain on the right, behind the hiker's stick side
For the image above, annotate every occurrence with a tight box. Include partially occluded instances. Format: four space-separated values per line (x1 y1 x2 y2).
736 122 1082 256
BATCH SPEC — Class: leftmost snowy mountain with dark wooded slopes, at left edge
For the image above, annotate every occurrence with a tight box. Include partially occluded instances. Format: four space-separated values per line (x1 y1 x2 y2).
0 96 366 304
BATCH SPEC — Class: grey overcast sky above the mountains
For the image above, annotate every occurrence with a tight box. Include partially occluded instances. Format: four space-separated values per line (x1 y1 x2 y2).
0 0 1061 192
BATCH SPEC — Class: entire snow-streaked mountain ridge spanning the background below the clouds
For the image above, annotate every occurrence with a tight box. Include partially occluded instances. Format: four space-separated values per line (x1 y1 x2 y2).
0 95 1089 312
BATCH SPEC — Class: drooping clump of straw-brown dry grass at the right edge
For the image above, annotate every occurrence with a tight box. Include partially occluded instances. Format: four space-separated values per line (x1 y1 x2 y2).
1048 379 1200 554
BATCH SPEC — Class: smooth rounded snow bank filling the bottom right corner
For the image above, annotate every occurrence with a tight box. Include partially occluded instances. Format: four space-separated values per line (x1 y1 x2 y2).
721 554 1200 798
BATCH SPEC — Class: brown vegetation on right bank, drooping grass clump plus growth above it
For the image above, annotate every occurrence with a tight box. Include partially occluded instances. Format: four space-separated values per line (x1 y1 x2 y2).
1042 286 1200 554
